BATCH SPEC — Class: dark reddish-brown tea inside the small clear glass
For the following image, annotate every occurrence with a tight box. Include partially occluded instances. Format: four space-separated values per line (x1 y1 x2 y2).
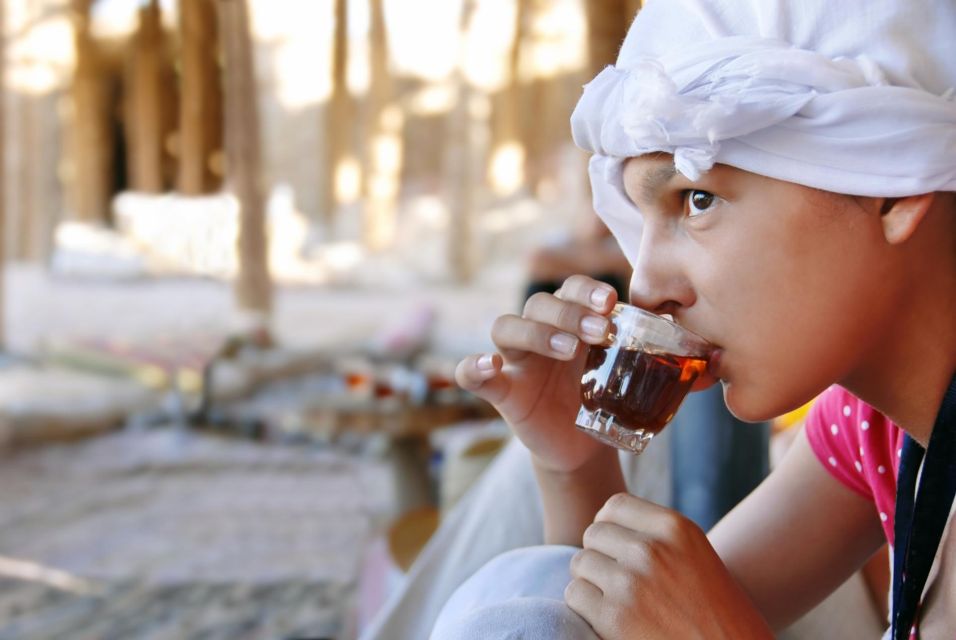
581 345 707 435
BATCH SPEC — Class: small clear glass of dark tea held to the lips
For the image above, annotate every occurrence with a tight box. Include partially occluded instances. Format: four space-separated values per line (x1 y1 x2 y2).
575 304 713 453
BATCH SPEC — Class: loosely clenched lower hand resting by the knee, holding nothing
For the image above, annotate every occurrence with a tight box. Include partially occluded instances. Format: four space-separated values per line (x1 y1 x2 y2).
564 493 773 640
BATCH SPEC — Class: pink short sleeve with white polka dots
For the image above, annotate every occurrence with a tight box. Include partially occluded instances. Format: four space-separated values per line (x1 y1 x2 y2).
806 386 904 545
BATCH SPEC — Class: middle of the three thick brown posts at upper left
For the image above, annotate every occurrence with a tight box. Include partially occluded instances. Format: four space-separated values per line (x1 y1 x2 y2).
126 0 164 193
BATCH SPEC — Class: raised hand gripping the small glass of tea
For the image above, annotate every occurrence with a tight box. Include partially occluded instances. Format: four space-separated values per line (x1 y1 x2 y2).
455 275 617 476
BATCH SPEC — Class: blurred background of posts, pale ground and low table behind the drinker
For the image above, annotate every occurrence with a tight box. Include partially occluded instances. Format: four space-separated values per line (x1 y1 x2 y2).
0 0 640 639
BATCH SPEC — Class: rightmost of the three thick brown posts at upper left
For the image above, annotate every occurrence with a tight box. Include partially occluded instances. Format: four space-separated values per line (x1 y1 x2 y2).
177 0 222 196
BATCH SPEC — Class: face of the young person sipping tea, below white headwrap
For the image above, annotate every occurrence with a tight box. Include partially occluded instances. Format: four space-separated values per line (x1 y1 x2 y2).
624 154 901 420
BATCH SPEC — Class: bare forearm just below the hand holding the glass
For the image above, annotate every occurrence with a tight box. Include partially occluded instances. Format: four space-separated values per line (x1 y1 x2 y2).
534 447 627 547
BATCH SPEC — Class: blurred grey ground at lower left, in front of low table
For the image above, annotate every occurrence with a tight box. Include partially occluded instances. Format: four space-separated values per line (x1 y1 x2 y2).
0 430 395 640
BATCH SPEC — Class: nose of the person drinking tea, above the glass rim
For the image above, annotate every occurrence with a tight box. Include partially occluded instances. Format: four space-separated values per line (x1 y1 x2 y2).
629 223 695 316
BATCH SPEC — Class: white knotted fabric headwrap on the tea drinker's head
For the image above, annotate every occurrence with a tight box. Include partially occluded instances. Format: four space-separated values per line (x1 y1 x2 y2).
571 0 956 264
